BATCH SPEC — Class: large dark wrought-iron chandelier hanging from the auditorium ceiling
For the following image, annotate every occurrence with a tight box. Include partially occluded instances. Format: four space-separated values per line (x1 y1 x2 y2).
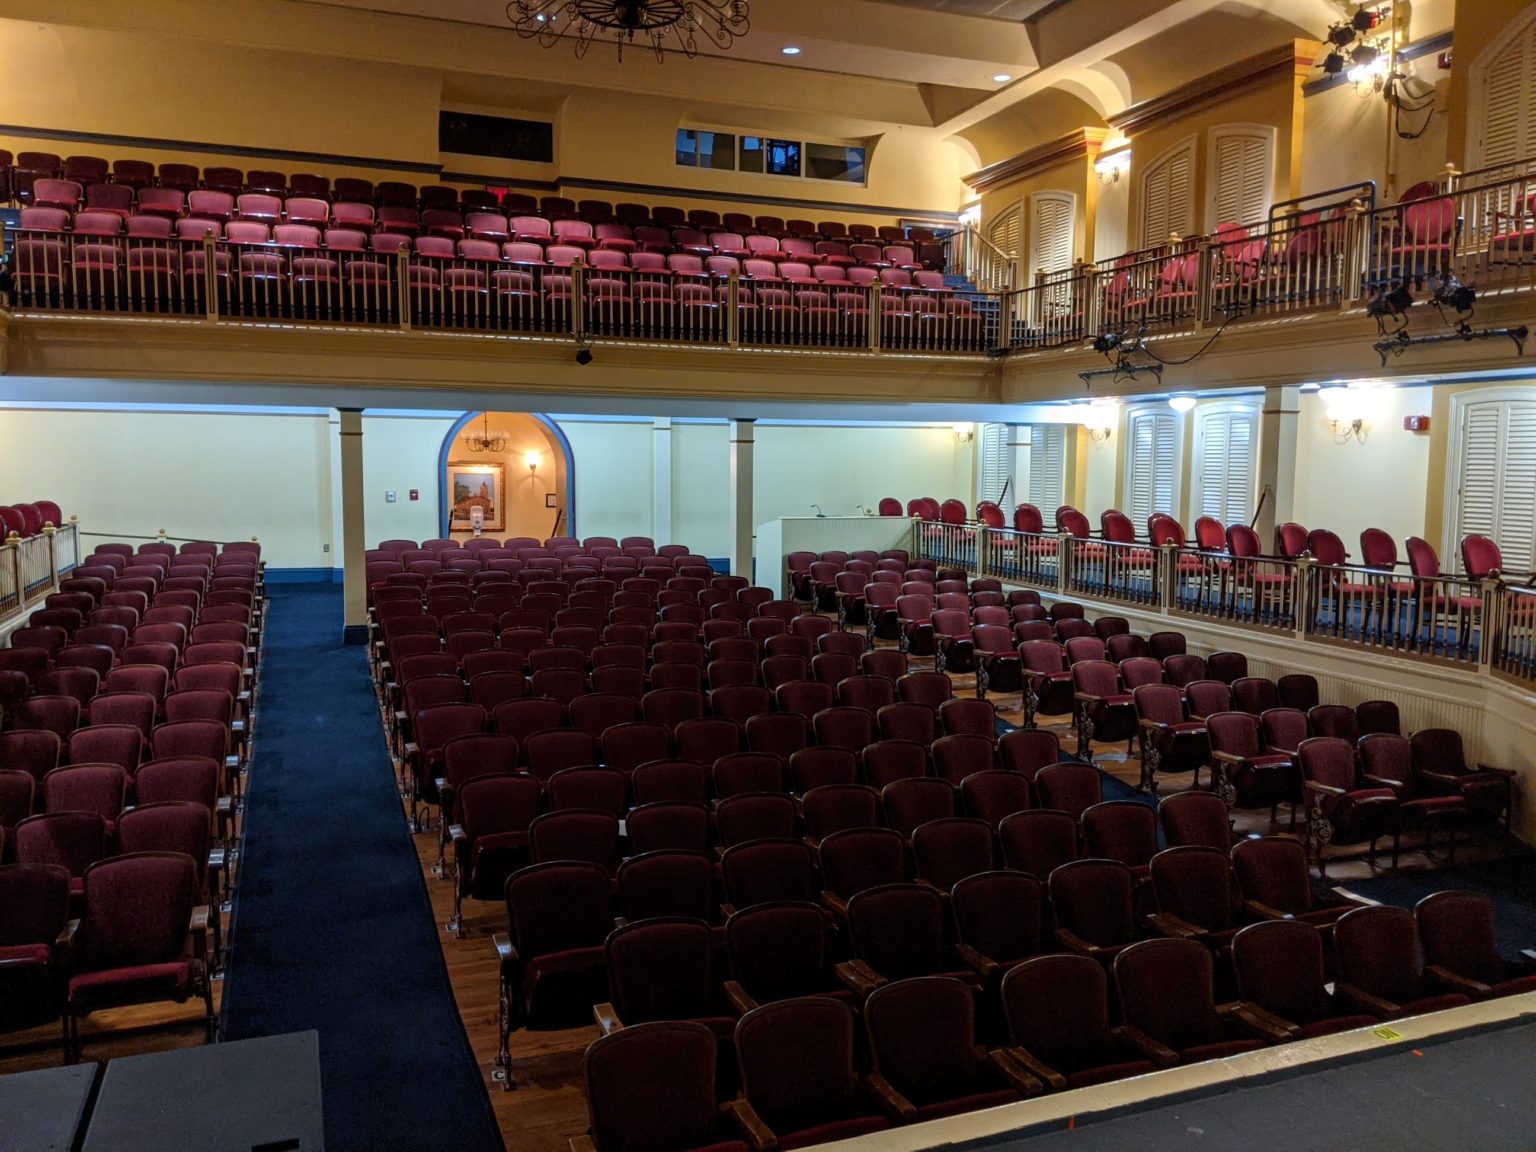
507 0 751 61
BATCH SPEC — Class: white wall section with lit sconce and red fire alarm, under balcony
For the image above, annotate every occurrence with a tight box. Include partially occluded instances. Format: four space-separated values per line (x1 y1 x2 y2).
1295 387 1432 558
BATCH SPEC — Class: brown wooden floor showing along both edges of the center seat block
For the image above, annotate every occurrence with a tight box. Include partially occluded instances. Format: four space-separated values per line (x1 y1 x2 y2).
387 660 1437 1152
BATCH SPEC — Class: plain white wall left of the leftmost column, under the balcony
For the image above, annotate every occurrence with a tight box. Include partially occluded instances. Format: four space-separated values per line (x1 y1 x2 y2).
0 409 332 568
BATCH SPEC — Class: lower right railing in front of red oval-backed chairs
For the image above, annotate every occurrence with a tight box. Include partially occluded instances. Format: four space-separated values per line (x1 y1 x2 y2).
914 521 1536 684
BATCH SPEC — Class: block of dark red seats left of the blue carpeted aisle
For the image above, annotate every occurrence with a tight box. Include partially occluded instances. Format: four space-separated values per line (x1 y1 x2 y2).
0 544 261 1061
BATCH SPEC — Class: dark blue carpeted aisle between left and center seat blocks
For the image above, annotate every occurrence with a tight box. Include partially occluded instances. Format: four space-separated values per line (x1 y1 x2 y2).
224 585 502 1152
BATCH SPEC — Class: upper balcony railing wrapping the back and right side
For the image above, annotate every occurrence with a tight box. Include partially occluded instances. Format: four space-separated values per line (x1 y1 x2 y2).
6 161 1536 356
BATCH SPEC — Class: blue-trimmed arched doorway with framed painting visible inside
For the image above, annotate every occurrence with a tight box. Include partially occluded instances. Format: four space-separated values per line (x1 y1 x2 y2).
438 412 576 541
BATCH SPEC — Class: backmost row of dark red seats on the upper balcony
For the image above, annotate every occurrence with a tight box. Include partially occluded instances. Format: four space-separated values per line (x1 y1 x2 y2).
0 151 934 243
